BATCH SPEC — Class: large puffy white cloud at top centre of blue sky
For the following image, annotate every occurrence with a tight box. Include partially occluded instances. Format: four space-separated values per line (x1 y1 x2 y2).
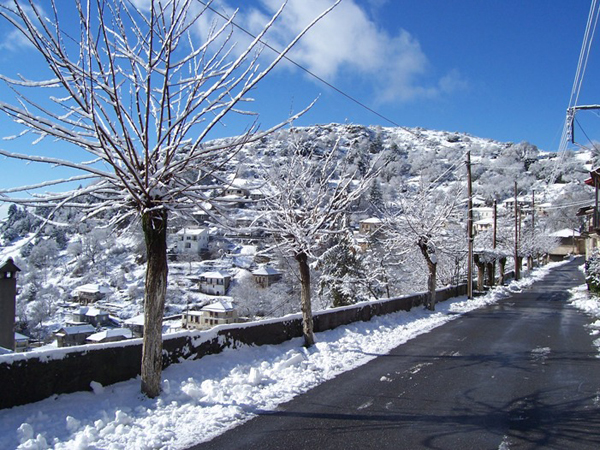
203 0 466 103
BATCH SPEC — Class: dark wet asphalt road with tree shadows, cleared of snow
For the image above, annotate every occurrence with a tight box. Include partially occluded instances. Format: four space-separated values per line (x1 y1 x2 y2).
194 260 600 450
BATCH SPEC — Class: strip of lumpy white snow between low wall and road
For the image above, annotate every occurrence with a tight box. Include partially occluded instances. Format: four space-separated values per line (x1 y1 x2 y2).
0 263 568 450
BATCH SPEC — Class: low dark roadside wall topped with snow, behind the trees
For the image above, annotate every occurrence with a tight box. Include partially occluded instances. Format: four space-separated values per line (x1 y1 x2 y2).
0 285 466 408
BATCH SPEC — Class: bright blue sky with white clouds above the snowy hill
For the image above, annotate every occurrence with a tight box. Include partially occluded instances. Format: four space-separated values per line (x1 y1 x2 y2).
0 0 600 217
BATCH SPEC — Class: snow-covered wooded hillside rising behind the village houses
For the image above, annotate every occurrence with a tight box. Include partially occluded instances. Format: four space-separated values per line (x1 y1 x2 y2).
0 124 592 340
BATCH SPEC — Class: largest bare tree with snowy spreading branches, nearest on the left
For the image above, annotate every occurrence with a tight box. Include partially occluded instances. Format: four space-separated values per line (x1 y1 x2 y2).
0 0 335 397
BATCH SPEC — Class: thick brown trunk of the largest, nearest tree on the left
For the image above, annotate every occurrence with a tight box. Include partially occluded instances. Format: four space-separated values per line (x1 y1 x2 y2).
142 210 168 398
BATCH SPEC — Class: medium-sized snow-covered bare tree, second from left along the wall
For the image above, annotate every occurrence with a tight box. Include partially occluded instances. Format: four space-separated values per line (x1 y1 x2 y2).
259 142 377 347
